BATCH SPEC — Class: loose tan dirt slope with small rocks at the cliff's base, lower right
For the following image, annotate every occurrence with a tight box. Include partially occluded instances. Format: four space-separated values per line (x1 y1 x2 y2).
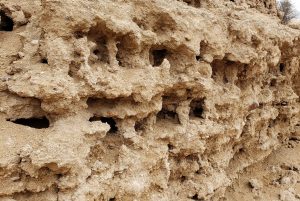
223 137 300 201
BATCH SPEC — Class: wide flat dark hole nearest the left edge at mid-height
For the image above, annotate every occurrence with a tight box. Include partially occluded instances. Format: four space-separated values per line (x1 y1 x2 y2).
7 117 50 129
